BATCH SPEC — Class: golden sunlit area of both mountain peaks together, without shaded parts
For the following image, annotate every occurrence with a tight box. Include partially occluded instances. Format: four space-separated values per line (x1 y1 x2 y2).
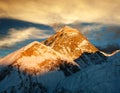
0 26 101 73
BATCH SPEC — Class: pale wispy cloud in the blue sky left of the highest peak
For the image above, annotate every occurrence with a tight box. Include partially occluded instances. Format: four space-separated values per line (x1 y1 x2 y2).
0 27 50 47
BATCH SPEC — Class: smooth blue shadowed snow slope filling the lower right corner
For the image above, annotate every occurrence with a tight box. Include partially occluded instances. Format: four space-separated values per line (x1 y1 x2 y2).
55 52 120 93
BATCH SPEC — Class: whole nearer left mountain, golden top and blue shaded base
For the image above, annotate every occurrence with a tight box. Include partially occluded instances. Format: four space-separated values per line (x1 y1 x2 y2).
0 41 79 93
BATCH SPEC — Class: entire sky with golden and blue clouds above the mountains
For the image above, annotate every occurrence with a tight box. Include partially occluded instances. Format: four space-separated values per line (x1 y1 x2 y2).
0 0 120 56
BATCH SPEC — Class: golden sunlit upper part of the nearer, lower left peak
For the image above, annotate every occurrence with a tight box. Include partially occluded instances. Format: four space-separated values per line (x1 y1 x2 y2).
0 41 79 74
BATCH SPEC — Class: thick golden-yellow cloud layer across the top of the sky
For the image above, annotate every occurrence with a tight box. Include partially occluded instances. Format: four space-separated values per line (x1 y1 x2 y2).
0 0 120 24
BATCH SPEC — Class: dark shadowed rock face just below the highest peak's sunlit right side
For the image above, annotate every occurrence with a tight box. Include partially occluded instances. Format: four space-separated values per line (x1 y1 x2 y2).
74 51 107 68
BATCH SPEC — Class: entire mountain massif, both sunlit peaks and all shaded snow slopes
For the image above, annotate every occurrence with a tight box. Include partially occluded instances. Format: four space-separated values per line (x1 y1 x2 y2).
0 27 120 93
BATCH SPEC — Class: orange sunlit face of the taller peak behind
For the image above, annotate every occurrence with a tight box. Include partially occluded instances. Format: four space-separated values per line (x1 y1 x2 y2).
44 26 98 59
